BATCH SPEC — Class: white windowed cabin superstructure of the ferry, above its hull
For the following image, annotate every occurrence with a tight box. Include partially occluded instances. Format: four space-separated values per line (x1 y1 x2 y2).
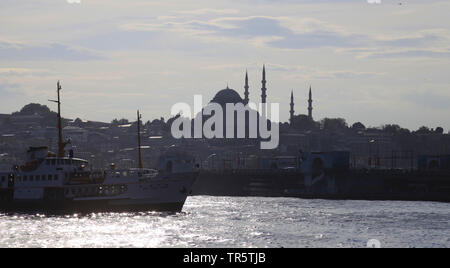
0 147 167 200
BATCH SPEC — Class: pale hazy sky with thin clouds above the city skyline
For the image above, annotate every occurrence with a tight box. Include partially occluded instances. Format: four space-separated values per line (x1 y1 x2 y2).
0 0 450 132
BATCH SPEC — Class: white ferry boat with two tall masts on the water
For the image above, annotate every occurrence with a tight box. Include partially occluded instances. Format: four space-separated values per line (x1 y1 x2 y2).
0 82 198 213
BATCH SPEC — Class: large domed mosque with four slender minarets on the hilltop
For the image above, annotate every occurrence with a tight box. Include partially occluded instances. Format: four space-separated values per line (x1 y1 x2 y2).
176 66 315 153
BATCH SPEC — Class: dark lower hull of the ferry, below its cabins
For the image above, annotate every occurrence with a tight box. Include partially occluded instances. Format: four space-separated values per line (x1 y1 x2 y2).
0 172 198 214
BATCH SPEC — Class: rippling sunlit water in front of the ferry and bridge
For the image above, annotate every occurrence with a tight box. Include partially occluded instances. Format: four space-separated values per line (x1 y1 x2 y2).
0 196 450 247
